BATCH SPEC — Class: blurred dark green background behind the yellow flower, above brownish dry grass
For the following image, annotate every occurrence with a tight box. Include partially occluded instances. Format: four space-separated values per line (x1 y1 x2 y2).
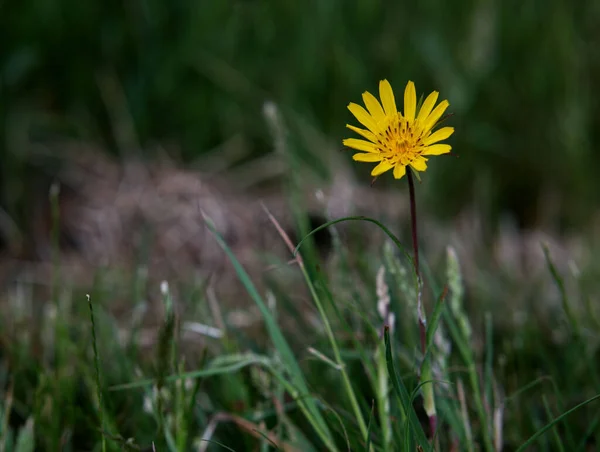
0 0 600 240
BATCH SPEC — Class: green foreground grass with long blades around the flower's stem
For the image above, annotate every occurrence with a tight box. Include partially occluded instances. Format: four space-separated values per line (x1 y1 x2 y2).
0 196 598 451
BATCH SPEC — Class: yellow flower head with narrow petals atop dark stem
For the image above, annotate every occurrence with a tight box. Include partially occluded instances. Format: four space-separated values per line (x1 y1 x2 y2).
344 80 454 179
